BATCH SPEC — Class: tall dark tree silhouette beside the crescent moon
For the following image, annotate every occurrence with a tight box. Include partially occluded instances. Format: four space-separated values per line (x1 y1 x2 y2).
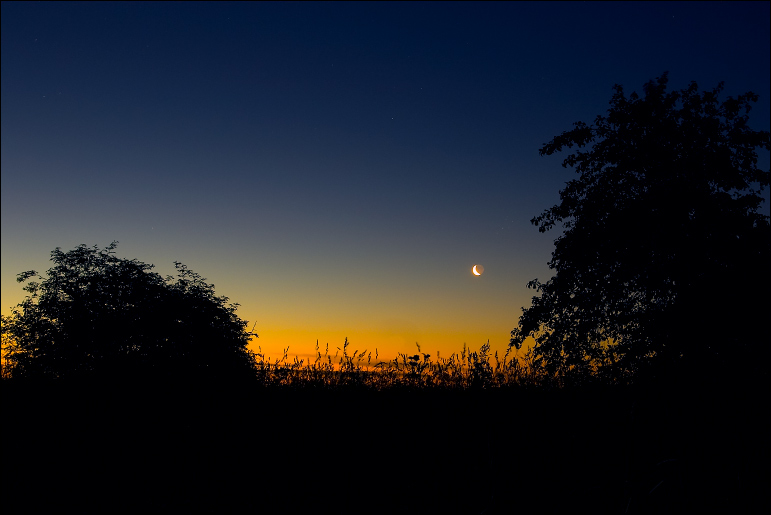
511 73 771 377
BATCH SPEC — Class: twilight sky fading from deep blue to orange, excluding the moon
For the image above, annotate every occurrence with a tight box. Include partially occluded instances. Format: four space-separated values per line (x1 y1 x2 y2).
0 2 771 359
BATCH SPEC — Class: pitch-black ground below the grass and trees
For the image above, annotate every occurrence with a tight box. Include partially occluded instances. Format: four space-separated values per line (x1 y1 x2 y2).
2 376 769 514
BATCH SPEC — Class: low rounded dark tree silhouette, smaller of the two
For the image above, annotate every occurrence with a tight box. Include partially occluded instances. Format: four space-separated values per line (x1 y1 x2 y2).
2 242 254 378
